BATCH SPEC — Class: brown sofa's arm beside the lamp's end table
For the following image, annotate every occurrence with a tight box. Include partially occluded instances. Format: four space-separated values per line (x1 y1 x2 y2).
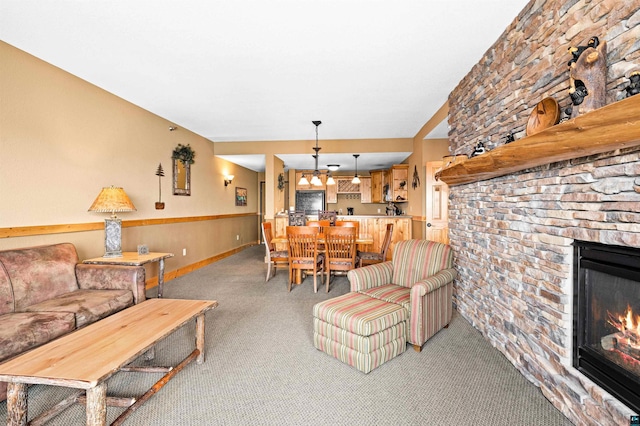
76 263 146 304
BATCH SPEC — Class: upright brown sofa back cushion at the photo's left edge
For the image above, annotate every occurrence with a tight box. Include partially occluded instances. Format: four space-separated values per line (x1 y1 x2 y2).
0 243 78 312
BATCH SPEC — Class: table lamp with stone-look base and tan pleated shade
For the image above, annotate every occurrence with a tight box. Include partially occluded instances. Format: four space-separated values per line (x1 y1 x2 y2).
89 185 136 257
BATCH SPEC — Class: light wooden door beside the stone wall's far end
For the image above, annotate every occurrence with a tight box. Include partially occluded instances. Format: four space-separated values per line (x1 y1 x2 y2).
425 161 449 244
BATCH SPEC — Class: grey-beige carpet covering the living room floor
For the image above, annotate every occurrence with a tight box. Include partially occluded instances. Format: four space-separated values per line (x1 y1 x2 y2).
0 246 571 426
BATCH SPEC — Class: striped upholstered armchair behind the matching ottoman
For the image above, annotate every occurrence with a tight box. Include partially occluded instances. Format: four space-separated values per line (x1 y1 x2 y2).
347 240 456 352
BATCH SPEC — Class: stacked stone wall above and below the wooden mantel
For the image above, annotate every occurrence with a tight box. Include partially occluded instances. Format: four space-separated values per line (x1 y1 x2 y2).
449 0 640 425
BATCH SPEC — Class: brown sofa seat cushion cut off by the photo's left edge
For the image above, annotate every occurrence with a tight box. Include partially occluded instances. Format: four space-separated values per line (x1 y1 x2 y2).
0 312 76 361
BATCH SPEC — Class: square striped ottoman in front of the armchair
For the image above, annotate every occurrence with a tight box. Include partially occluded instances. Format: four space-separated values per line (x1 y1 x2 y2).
313 293 407 374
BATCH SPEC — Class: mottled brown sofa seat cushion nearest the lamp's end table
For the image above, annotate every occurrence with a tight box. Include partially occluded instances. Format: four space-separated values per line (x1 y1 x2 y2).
27 290 133 327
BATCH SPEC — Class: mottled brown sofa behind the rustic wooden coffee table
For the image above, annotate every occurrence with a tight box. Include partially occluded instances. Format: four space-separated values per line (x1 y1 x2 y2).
0 243 145 401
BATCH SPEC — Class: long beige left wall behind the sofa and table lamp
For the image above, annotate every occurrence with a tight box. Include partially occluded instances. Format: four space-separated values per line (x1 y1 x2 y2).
0 42 259 276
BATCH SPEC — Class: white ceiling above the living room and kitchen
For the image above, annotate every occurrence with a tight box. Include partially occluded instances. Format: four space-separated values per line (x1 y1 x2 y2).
0 0 528 170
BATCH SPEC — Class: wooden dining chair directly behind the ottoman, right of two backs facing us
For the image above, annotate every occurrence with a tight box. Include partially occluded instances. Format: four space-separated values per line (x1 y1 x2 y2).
324 226 358 293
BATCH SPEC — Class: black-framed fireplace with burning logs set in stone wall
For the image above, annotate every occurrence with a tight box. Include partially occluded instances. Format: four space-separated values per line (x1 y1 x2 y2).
573 241 640 412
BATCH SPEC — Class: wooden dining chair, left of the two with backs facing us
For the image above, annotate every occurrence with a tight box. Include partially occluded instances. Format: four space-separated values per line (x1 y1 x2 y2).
287 226 324 293
